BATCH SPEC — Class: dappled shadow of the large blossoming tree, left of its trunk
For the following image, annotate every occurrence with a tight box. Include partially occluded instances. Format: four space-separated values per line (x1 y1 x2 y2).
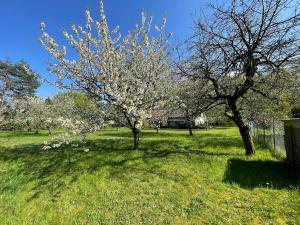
0 140 134 200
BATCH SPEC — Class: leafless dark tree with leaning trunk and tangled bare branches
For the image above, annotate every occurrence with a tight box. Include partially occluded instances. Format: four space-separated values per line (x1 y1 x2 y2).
181 0 300 155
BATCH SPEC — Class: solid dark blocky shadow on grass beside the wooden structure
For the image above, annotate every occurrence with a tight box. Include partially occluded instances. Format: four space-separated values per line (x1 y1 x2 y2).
223 159 300 189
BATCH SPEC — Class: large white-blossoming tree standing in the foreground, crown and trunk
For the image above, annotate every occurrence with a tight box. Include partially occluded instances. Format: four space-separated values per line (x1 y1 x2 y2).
40 1 171 149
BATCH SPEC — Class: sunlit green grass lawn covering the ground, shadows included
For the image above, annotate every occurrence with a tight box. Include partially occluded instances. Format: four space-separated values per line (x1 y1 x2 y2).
0 128 300 225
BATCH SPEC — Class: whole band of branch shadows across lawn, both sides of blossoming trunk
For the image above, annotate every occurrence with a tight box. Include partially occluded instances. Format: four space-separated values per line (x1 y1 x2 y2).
0 134 246 201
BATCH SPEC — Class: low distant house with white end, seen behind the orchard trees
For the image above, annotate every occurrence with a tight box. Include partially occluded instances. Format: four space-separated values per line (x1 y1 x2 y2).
167 113 207 128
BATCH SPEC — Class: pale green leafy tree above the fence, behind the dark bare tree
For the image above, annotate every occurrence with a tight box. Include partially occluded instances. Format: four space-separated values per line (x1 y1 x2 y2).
244 73 299 126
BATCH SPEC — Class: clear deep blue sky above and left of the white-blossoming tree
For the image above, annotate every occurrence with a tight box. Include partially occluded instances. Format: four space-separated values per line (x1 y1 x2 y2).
0 0 205 97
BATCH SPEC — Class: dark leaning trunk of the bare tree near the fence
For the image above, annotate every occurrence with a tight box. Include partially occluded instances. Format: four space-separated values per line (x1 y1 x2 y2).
226 102 255 155
